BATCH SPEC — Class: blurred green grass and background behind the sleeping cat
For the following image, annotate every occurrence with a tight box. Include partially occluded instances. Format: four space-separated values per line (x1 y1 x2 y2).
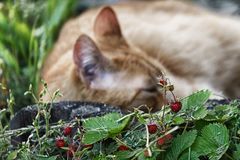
0 0 240 110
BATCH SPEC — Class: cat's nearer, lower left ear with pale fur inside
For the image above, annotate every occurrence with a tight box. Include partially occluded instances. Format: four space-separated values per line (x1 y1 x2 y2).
73 35 114 89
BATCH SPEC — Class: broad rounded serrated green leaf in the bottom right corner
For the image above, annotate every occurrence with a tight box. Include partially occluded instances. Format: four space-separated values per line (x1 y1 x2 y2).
192 123 229 160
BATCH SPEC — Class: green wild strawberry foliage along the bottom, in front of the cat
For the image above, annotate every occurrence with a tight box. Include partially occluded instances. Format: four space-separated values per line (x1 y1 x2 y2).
0 91 240 160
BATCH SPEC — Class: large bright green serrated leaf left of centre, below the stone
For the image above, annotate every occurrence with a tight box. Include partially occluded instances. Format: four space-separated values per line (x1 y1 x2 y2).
83 113 130 144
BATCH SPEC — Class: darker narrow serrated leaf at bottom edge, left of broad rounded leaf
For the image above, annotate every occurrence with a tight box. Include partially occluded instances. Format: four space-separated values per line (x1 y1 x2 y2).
165 130 197 160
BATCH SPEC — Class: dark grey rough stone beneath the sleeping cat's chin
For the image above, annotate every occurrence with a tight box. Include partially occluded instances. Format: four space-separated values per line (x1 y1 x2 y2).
10 101 123 146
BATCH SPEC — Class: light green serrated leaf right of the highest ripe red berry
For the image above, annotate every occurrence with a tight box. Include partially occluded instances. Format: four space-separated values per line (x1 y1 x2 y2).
181 90 211 111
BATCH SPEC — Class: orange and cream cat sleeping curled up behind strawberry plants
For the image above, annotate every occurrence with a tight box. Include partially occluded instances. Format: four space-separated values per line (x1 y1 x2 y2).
42 1 240 110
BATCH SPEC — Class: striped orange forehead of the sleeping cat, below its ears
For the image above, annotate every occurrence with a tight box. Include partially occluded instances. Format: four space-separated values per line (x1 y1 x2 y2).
96 38 161 76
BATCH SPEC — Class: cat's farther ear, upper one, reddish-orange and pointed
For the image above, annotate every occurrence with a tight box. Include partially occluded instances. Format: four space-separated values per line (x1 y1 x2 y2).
94 7 122 38
